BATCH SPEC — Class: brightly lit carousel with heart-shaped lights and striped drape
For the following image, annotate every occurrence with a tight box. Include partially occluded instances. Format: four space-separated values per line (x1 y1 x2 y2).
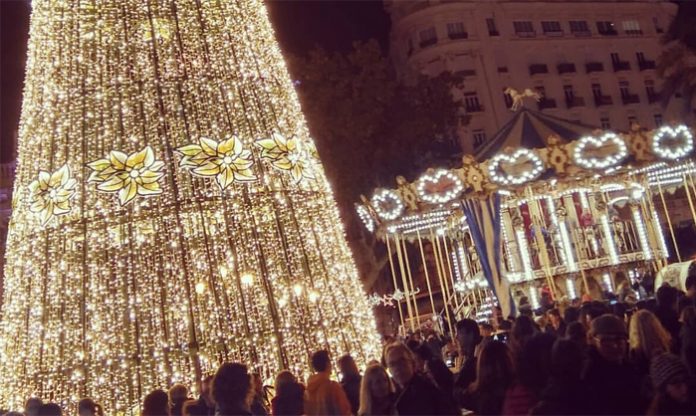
357 99 696 331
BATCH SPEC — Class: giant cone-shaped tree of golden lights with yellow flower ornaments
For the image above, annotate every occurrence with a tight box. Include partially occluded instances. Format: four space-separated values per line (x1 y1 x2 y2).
0 0 378 413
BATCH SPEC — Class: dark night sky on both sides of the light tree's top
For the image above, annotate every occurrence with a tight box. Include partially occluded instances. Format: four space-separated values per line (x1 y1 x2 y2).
0 0 389 163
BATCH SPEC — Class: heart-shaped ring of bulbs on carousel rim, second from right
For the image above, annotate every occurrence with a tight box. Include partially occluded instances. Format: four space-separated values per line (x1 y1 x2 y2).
573 133 628 169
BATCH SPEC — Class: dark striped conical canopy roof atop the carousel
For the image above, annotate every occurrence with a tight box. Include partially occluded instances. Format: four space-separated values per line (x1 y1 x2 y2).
475 107 597 160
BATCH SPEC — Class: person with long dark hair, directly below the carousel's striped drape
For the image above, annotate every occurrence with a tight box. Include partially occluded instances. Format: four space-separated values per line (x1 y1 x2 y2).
459 341 515 415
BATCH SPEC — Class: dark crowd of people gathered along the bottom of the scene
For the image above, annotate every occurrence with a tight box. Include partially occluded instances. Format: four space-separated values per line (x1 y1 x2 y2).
7 275 696 416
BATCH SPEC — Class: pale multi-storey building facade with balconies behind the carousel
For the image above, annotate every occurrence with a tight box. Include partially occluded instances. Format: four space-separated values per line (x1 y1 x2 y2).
385 0 690 154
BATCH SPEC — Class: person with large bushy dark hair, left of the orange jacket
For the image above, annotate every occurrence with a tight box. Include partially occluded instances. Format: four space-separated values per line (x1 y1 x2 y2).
212 363 254 416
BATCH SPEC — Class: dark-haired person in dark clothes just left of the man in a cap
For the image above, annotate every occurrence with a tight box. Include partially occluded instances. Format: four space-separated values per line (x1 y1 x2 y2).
530 340 594 415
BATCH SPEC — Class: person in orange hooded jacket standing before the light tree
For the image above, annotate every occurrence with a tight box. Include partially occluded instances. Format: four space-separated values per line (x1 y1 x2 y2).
305 350 351 416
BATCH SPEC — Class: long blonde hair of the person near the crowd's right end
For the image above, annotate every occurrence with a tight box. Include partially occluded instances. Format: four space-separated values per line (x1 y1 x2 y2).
628 309 672 359
